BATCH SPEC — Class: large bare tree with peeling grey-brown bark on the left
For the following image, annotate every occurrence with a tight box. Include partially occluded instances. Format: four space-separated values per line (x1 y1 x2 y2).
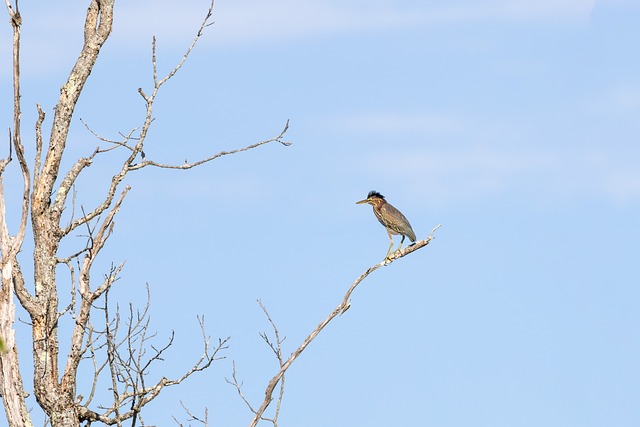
0 0 289 427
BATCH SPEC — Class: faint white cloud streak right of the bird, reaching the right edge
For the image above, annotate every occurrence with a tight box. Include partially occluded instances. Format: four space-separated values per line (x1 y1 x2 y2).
368 145 640 205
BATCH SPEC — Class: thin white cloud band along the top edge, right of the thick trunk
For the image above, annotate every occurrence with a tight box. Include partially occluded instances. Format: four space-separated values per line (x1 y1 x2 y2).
107 0 595 46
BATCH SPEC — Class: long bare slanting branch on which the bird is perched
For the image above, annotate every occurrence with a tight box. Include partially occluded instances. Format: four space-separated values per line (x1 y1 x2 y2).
249 225 440 427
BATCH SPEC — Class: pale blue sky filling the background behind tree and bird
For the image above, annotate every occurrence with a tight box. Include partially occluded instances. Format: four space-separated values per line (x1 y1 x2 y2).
0 0 640 427
